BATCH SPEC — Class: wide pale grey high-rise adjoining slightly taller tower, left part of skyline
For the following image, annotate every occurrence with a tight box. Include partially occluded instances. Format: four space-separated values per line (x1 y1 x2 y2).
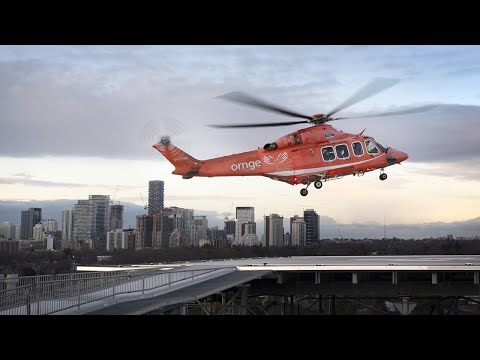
73 200 97 243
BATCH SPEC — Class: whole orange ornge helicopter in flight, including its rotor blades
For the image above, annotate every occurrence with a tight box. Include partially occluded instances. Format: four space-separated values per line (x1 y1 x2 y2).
152 78 437 196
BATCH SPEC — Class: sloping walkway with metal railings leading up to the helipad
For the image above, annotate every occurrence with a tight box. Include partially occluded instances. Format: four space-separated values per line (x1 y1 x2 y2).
0 269 218 315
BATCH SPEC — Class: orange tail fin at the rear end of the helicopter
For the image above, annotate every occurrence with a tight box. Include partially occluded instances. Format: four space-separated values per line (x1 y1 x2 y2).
152 136 201 179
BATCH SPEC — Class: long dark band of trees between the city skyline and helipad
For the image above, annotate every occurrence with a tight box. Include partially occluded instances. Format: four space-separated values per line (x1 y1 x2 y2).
0 239 480 276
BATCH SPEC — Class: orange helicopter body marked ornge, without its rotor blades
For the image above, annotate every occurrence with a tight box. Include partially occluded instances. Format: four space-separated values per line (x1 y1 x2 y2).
153 124 408 188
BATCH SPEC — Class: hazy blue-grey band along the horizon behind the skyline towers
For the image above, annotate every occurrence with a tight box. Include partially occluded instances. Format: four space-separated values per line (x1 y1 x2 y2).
0 200 480 239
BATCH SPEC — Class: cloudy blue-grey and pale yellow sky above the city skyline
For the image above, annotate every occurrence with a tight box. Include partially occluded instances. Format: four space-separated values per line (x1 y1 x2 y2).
0 45 480 228
